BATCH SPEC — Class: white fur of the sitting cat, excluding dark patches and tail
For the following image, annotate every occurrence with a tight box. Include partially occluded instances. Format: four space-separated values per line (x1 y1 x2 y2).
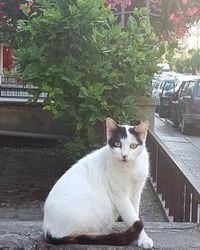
43 123 153 248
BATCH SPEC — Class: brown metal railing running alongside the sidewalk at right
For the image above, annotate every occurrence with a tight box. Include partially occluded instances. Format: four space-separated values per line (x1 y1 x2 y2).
147 131 200 223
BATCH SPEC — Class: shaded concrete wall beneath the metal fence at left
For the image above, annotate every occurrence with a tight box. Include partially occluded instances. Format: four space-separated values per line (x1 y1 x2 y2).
0 103 69 136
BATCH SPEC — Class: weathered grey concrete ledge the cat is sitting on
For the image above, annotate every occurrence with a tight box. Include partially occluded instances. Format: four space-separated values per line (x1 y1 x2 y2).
0 221 200 250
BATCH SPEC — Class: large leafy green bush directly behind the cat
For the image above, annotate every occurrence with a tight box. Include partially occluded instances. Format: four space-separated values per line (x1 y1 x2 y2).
15 0 158 144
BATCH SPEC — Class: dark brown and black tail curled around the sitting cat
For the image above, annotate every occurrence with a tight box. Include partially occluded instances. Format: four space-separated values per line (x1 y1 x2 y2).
46 221 144 246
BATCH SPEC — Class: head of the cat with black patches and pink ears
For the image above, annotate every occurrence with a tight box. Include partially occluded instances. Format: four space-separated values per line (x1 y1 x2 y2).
106 118 149 163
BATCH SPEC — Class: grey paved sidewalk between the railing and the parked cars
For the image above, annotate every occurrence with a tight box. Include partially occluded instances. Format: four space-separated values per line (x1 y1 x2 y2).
154 115 200 193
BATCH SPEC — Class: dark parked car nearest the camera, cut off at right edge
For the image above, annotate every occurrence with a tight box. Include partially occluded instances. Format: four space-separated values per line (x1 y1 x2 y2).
171 77 200 134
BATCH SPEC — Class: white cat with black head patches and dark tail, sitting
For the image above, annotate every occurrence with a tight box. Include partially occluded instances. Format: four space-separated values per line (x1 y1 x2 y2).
43 118 153 249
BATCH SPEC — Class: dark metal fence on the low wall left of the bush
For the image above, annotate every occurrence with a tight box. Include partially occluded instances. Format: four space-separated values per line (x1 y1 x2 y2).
0 77 47 99
